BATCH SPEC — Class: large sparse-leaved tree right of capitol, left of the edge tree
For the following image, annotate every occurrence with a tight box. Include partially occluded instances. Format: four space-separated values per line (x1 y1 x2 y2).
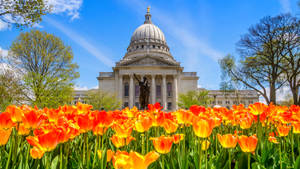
220 14 298 104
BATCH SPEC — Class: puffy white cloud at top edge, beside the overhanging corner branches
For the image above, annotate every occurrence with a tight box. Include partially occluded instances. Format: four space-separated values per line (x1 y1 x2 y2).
46 0 83 20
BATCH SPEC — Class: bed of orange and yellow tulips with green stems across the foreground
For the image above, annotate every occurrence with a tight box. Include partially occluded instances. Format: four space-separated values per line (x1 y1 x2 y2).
0 103 300 169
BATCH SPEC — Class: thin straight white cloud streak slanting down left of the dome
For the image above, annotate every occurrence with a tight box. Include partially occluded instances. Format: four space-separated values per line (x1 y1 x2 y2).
45 17 114 67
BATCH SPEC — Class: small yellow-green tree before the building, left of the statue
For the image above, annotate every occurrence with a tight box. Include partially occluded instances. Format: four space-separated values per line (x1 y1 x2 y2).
84 89 122 111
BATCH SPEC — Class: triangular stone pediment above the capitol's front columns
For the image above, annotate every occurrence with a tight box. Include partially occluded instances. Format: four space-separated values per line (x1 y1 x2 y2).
117 56 177 66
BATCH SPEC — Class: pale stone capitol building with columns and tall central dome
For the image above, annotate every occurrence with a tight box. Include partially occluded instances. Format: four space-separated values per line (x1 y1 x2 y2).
75 7 259 110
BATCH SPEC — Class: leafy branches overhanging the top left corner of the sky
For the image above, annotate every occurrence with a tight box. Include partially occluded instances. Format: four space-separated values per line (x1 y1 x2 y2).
0 0 49 27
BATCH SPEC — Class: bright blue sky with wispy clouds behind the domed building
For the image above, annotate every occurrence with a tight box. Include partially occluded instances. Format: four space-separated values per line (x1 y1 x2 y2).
0 0 300 89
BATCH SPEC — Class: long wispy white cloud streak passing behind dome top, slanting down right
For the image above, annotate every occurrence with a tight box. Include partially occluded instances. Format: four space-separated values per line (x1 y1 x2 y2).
118 0 224 70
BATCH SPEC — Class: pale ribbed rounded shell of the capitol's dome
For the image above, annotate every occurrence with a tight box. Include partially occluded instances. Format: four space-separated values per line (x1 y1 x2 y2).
131 23 166 43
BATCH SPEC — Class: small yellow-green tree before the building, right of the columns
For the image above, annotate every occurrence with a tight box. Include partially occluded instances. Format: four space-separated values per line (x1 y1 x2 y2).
178 90 211 109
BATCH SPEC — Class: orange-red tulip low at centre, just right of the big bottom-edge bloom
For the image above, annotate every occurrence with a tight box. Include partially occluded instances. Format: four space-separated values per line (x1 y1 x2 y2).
150 135 174 154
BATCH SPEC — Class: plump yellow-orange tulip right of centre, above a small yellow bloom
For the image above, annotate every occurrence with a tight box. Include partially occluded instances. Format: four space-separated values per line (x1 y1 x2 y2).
193 118 214 138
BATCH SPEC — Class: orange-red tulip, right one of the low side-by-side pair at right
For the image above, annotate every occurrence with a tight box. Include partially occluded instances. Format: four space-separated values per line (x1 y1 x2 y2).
238 135 258 153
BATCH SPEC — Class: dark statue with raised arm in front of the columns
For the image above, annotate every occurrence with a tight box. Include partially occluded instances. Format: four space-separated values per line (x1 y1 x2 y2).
133 74 150 110
